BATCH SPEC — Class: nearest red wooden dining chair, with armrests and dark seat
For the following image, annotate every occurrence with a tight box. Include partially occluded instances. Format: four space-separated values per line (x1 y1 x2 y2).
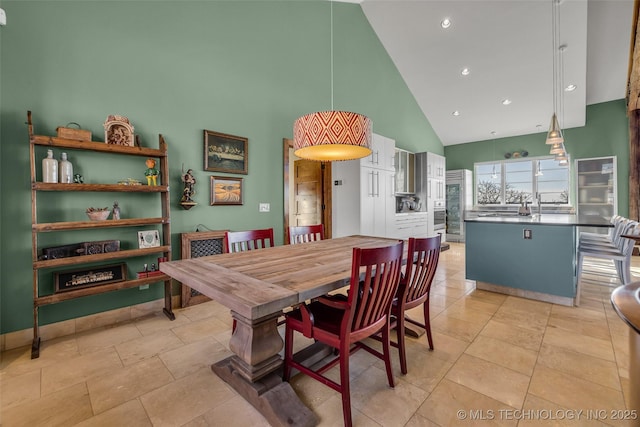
283 241 404 426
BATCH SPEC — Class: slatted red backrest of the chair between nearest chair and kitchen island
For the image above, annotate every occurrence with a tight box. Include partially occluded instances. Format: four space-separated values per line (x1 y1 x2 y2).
398 235 440 308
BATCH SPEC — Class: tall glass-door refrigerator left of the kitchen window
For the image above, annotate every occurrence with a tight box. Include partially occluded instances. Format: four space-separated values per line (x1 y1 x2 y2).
446 169 473 242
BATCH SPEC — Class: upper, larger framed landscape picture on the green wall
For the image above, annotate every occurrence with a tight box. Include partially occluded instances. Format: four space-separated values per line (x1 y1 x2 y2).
204 129 249 175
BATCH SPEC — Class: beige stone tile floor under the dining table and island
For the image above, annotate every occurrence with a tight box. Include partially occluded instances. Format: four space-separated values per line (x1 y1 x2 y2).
0 244 640 427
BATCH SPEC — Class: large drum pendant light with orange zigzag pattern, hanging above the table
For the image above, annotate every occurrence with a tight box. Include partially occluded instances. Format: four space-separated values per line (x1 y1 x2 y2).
293 1 372 161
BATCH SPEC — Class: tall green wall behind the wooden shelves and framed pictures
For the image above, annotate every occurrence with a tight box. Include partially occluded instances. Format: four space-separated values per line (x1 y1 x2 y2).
0 0 444 333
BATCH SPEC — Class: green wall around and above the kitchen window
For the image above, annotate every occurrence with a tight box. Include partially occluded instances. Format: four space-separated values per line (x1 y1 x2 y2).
444 99 629 216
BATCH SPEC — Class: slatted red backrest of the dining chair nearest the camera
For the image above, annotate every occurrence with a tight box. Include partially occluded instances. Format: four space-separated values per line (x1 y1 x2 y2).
342 241 404 341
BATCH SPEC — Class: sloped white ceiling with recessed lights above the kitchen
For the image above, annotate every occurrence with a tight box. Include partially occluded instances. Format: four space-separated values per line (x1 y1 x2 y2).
347 0 633 145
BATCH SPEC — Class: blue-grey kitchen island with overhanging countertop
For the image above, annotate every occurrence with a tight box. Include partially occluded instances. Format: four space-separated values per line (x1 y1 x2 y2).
465 214 611 306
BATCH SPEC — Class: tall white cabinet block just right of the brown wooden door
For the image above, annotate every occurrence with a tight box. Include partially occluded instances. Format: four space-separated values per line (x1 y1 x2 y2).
331 134 396 237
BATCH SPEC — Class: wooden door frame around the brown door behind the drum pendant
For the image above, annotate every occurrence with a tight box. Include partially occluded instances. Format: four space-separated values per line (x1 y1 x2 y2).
282 138 332 245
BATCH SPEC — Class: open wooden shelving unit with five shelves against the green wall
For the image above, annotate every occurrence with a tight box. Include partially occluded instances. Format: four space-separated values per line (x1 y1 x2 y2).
27 111 175 359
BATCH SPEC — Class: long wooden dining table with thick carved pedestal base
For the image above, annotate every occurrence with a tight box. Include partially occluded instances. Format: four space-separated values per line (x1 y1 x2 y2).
160 236 397 426
